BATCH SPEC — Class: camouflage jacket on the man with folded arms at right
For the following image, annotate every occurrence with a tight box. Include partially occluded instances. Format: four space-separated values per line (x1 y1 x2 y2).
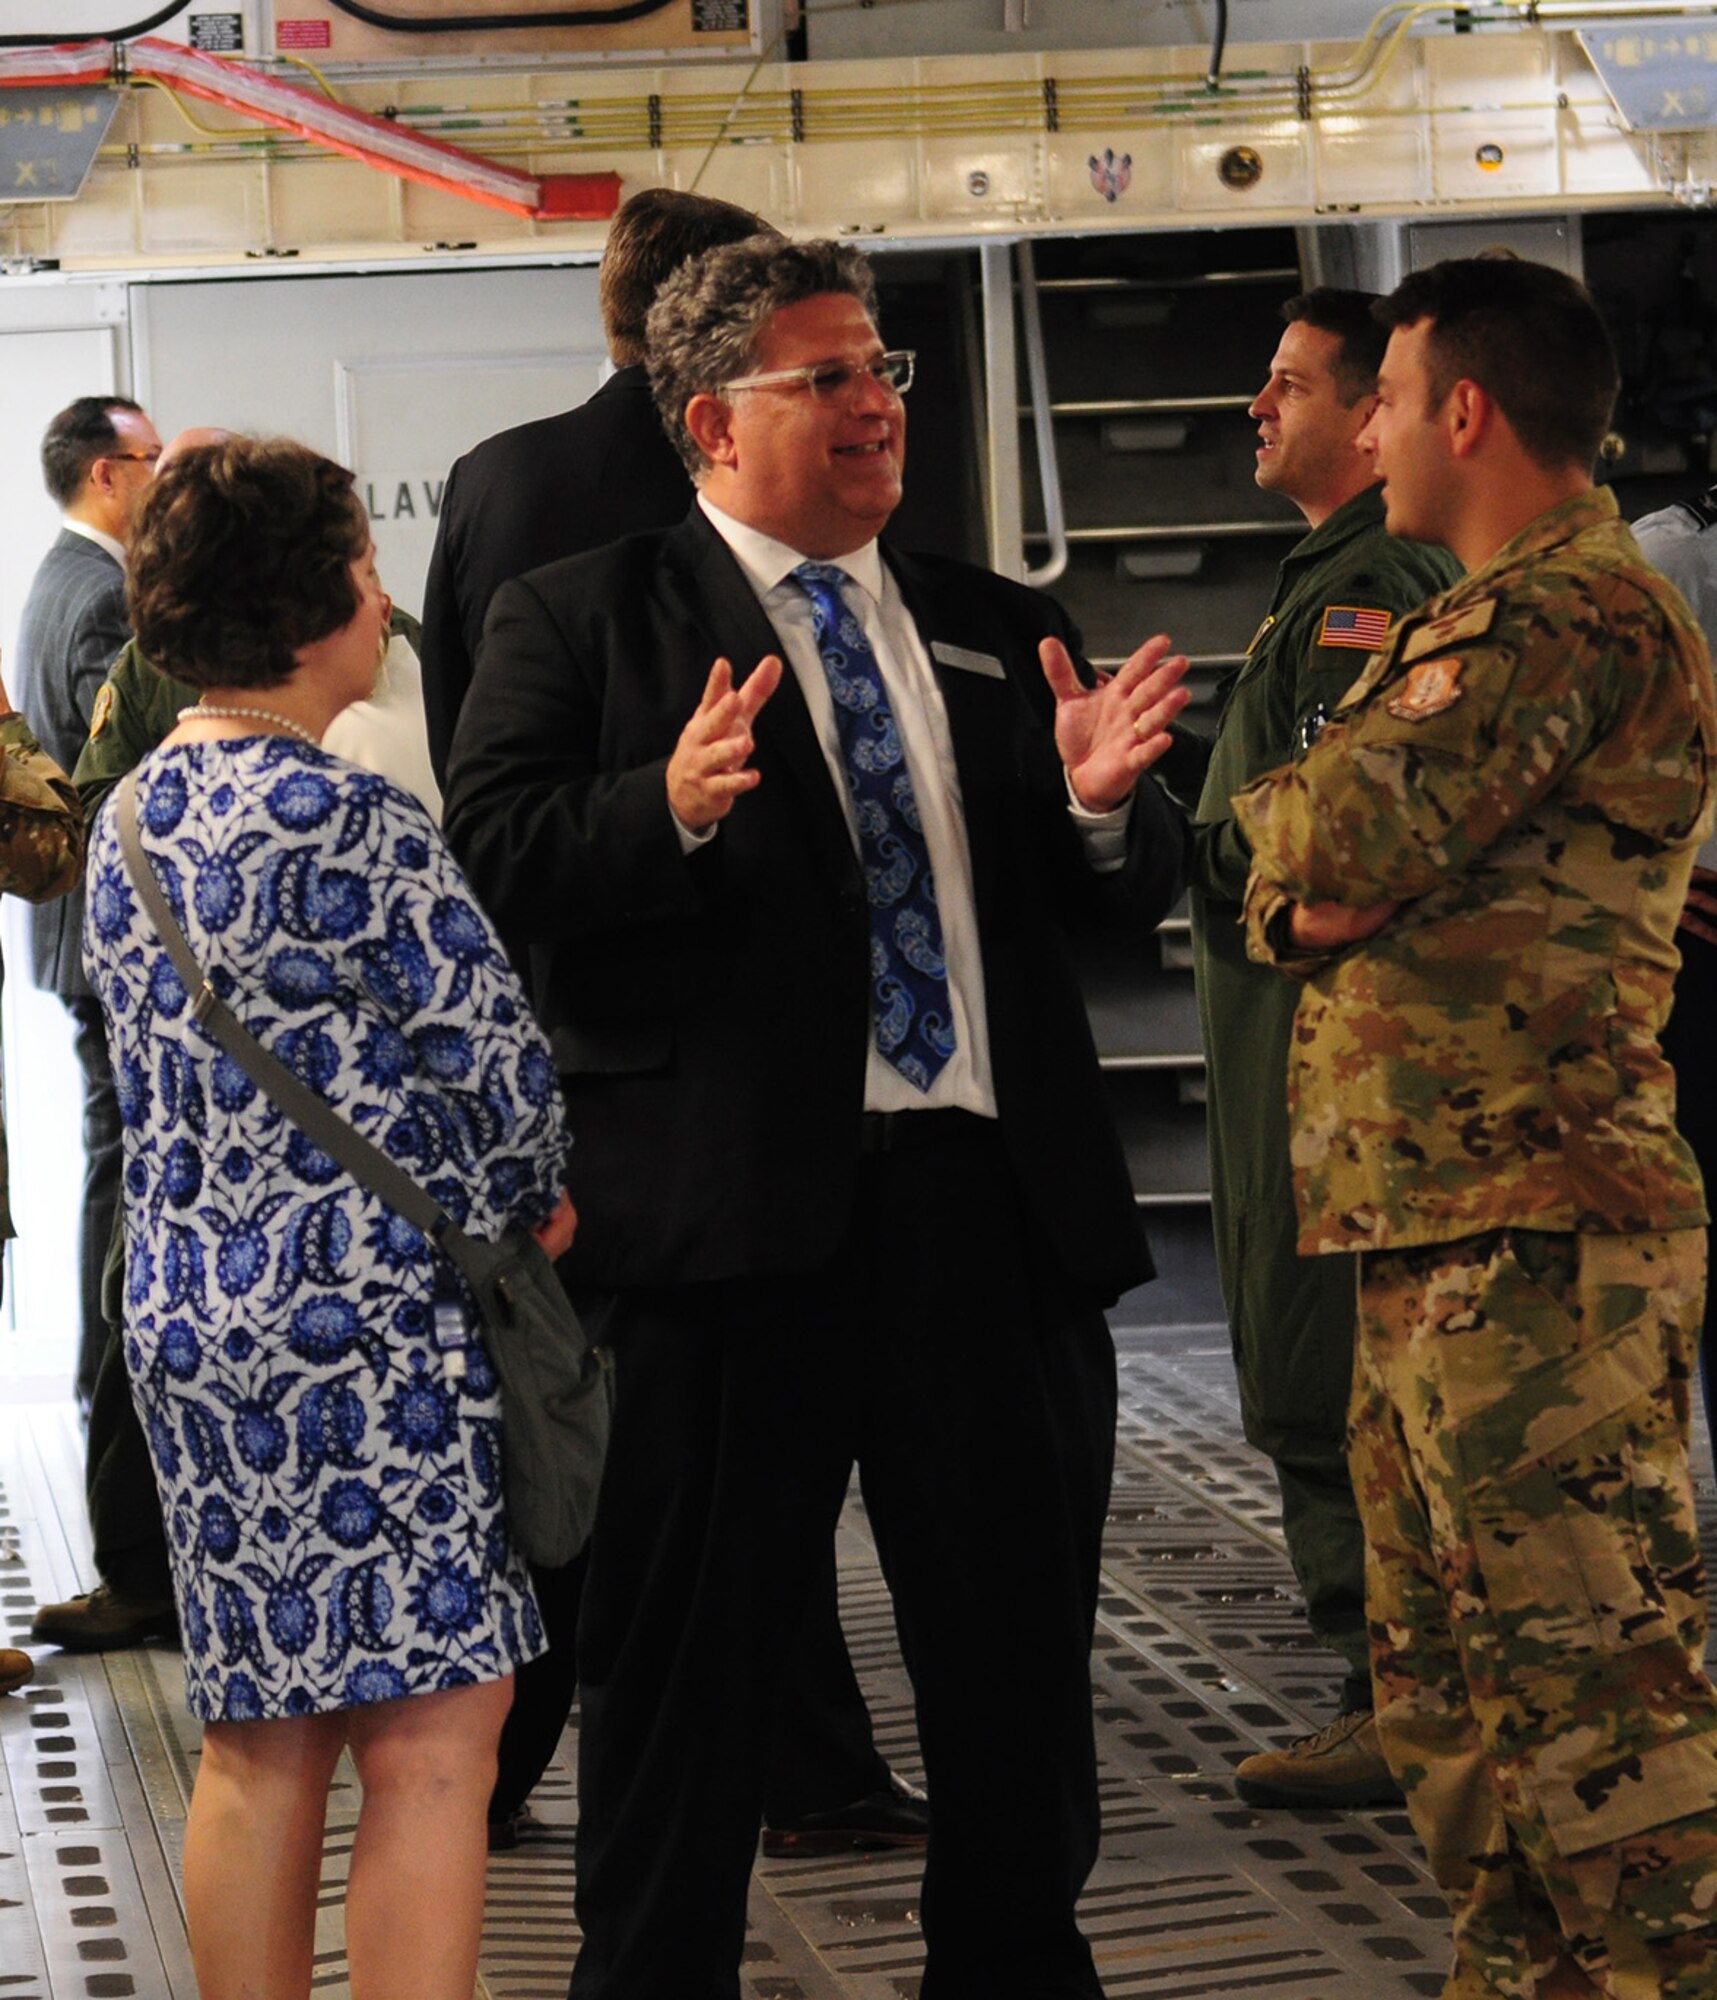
1235 490 1717 1252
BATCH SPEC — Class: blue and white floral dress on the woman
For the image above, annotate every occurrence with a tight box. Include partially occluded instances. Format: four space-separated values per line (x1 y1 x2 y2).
84 736 566 1720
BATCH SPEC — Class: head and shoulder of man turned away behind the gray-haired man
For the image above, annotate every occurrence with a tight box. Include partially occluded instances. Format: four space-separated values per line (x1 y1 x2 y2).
422 188 768 784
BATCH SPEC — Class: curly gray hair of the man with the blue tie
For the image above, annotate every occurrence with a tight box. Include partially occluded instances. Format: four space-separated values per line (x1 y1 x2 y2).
644 236 877 480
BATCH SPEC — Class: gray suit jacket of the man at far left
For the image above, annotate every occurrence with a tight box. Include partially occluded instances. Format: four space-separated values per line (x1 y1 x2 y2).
12 528 132 1000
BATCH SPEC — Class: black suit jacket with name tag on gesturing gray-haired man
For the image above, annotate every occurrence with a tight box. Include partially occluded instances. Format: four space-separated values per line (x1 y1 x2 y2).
446 508 1181 1296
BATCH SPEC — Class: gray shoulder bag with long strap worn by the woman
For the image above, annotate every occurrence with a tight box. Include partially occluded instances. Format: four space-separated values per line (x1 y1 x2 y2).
114 772 610 1568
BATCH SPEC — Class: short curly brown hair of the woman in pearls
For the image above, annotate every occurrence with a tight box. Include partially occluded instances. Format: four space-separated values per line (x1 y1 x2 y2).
126 438 370 688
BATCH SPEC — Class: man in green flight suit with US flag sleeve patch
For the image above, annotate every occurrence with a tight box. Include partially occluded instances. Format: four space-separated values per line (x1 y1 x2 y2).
1159 288 1461 1806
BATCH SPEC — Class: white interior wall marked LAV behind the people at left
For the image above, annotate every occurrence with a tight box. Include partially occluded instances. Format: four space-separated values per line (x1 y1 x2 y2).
0 266 602 1378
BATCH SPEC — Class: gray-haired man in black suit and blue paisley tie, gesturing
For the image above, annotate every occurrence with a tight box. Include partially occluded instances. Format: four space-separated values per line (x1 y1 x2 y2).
446 240 1185 2000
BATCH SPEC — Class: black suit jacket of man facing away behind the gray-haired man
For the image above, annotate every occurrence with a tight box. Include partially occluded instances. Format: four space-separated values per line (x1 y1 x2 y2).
420 368 692 786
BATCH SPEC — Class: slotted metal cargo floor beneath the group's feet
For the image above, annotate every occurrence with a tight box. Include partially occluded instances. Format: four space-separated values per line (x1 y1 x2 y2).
0 1326 1711 2000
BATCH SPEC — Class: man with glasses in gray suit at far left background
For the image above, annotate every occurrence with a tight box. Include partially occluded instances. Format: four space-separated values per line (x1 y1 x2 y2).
18 396 160 1406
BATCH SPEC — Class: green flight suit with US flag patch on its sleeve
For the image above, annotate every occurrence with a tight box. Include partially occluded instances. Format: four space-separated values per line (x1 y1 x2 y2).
1163 486 1461 1708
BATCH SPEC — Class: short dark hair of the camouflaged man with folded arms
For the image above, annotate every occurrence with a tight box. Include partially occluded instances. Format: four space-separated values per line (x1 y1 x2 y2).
1375 256 1621 472
